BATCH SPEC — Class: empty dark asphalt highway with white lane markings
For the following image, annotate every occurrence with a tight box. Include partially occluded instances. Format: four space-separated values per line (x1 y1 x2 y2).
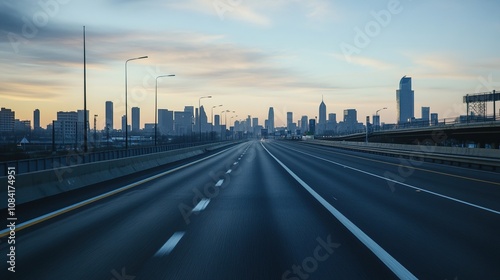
0 140 500 280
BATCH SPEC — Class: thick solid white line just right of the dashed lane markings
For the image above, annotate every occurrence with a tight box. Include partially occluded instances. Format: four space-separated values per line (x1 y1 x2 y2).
261 143 417 279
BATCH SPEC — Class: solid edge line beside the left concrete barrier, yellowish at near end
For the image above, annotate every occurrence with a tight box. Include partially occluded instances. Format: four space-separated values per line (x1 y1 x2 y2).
0 147 237 238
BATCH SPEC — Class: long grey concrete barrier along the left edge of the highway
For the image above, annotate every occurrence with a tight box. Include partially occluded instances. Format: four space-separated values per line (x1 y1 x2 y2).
0 142 239 209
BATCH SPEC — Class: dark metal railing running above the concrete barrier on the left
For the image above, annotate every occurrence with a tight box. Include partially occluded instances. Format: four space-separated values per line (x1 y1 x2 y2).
0 141 227 177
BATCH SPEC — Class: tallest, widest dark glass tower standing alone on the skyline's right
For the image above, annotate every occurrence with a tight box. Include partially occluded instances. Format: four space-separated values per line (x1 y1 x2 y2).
396 76 415 124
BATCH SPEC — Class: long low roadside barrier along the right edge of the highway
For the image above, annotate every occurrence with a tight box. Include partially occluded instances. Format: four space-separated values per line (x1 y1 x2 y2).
304 142 500 171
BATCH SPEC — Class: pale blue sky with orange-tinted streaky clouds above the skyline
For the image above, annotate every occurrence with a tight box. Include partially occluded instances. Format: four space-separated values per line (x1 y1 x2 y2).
0 0 500 129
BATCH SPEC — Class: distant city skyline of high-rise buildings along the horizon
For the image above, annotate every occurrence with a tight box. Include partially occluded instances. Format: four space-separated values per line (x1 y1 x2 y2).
0 76 467 146
